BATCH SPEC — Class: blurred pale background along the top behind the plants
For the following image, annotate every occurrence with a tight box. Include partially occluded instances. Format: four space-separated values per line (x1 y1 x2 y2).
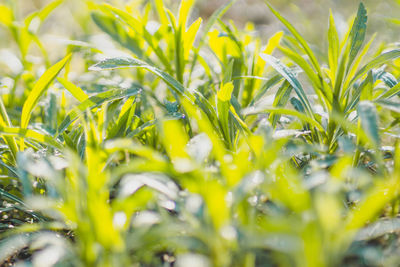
0 0 400 67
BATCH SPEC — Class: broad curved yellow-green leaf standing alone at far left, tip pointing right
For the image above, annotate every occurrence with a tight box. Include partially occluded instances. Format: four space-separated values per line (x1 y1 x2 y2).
21 54 72 128
